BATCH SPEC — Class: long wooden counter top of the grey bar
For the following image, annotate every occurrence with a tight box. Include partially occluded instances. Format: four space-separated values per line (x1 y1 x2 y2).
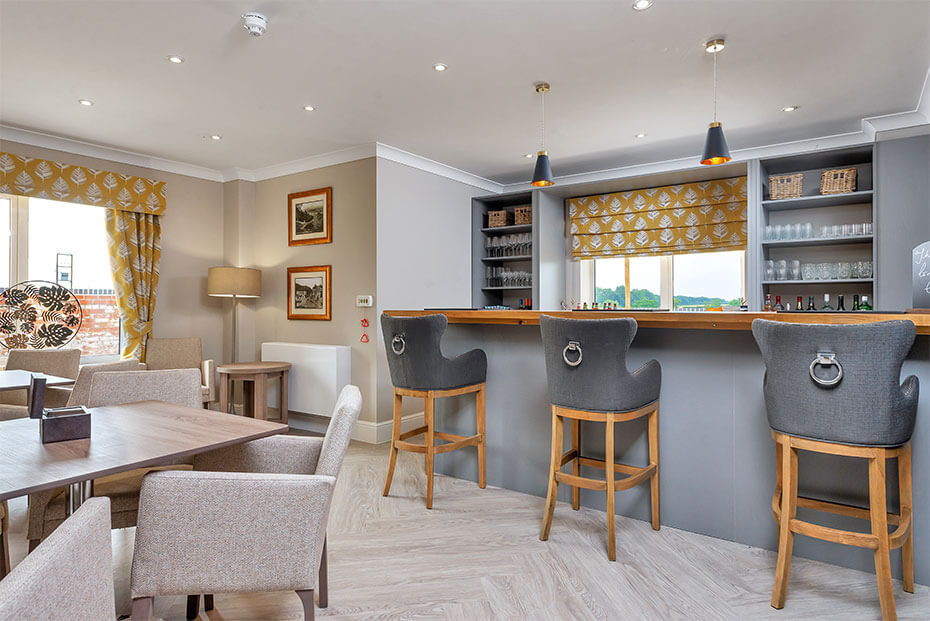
384 309 930 334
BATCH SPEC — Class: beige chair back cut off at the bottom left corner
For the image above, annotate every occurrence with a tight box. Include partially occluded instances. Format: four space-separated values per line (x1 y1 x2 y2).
0 498 116 621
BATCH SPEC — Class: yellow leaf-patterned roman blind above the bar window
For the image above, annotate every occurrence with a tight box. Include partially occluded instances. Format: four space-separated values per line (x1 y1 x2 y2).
568 177 746 259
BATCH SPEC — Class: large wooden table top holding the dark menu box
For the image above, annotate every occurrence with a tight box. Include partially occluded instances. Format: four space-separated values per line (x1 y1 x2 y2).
0 401 288 501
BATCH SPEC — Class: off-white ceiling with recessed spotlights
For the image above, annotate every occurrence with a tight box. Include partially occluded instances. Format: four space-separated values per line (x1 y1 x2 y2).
0 0 930 183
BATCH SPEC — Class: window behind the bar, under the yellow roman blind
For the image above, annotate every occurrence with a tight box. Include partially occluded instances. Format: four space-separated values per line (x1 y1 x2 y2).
588 250 746 311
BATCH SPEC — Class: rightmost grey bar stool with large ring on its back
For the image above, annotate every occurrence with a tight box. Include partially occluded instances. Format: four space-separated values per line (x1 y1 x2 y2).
752 319 918 620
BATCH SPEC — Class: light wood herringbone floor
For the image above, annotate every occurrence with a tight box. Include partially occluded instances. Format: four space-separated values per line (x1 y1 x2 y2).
3 443 930 621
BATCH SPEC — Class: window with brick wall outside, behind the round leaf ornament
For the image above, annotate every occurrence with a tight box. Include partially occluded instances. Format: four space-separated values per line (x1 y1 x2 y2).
0 195 120 357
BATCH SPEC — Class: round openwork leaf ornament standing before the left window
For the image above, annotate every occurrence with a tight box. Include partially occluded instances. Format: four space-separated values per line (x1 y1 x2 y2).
0 280 84 349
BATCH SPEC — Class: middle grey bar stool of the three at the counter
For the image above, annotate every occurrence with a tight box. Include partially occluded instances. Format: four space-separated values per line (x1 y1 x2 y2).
539 315 662 561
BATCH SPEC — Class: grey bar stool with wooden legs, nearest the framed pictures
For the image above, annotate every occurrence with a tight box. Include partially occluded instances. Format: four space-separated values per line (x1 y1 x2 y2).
381 314 488 509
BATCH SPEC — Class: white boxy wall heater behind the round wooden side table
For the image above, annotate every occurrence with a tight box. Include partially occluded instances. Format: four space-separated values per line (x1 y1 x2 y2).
262 343 352 416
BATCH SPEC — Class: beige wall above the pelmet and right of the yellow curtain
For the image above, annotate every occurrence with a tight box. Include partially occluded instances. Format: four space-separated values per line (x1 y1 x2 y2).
0 140 224 360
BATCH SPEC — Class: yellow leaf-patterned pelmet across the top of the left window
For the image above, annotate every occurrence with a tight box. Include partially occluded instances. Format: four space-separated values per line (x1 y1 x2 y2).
0 152 166 216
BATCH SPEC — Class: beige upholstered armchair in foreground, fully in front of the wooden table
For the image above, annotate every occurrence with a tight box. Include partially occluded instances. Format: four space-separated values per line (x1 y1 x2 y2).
130 385 362 621
